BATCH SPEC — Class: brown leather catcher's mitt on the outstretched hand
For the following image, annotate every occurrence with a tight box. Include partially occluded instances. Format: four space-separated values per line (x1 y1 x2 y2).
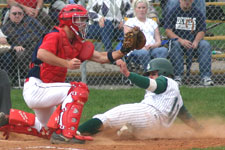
121 26 146 54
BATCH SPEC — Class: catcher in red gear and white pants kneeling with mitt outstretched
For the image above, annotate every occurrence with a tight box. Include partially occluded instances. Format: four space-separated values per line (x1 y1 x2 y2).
0 4 145 144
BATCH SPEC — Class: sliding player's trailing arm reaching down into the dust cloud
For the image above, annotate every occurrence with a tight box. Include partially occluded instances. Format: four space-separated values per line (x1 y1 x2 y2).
177 105 203 131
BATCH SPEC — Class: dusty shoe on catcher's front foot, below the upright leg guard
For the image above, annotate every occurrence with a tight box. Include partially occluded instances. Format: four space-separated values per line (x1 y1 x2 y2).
50 132 85 144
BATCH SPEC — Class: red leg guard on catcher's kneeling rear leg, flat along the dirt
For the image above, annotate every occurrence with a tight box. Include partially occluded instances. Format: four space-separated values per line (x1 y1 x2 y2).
0 109 52 139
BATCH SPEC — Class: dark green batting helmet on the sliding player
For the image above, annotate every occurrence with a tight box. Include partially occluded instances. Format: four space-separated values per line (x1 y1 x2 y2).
144 58 174 78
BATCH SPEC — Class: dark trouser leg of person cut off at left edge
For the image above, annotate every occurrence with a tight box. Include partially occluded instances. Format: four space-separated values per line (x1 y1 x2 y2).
0 69 12 115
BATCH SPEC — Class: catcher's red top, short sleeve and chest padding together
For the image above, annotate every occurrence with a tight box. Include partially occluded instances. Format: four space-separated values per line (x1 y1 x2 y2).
39 27 93 83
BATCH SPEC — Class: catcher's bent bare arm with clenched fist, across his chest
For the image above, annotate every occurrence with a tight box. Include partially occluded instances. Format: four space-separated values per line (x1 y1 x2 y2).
37 49 81 69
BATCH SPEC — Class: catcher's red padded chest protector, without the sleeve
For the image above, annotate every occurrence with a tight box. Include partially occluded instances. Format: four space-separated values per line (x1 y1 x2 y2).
40 27 83 83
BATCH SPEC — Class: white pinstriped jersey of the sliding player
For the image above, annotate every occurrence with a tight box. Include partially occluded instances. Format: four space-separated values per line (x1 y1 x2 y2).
141 77 183 127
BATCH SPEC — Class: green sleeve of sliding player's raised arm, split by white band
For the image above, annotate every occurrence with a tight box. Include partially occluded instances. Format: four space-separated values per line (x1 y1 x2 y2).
128 72 167 94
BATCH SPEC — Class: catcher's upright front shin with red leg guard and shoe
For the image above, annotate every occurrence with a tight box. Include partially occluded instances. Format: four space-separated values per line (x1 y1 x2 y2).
48 82 93 144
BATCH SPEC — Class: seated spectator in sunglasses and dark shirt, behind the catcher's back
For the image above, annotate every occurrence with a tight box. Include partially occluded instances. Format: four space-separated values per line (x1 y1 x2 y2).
2 4 47 84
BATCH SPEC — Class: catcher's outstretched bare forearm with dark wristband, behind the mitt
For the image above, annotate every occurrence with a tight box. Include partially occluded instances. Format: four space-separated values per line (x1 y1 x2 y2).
90 50 124 64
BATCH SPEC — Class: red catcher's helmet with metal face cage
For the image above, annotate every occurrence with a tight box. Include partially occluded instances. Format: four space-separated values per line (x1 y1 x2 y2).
58 4 88 39
